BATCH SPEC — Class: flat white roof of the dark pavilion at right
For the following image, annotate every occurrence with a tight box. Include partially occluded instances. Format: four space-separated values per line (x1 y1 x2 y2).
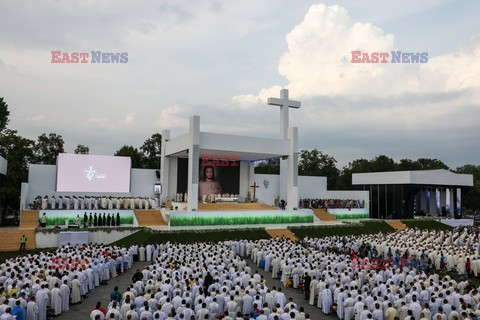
352 169 473 187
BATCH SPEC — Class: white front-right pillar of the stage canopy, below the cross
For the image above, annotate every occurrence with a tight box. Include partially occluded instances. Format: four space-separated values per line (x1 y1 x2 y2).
287 127 298 210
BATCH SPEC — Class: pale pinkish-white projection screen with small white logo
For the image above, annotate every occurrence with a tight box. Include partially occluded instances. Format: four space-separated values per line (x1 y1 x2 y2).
57 153 131 193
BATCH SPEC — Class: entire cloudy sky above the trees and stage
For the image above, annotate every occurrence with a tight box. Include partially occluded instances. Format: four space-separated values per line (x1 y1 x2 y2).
0 0 480 167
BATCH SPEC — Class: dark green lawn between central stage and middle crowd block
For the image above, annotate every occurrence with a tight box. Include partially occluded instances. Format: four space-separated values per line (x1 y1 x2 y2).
111 229 270 246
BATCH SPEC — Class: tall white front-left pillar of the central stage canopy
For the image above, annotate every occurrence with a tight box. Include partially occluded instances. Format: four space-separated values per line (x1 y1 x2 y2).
187 116 200 211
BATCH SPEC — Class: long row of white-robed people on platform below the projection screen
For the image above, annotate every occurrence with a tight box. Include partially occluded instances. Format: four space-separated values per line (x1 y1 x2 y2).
30 196 157 210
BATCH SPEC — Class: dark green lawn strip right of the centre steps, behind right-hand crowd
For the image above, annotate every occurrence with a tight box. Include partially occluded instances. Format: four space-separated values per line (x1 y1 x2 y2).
288 221 395 239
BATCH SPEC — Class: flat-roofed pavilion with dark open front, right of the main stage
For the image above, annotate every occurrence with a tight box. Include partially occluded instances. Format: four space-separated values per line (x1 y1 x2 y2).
352 169 473 219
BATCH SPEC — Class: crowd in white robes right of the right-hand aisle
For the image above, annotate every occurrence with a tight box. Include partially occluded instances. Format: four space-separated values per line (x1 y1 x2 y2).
246 227 480 320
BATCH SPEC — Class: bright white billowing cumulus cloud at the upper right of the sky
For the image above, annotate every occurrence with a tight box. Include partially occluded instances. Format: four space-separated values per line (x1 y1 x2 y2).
233 4 480 103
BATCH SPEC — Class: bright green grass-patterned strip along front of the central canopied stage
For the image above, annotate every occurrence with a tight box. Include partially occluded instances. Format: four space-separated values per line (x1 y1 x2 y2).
170 215 313 227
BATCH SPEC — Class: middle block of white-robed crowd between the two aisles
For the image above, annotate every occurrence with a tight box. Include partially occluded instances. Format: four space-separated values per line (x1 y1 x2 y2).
101 241 310 320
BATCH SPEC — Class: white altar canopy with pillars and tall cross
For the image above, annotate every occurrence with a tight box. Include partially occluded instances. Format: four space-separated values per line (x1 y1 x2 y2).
161 89 300 211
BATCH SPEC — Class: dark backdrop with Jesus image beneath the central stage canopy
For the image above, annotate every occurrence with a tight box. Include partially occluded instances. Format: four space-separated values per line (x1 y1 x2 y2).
177 158 240 199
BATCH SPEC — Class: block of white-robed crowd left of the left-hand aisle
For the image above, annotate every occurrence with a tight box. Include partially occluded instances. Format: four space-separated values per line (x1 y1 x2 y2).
0 245 133 320
